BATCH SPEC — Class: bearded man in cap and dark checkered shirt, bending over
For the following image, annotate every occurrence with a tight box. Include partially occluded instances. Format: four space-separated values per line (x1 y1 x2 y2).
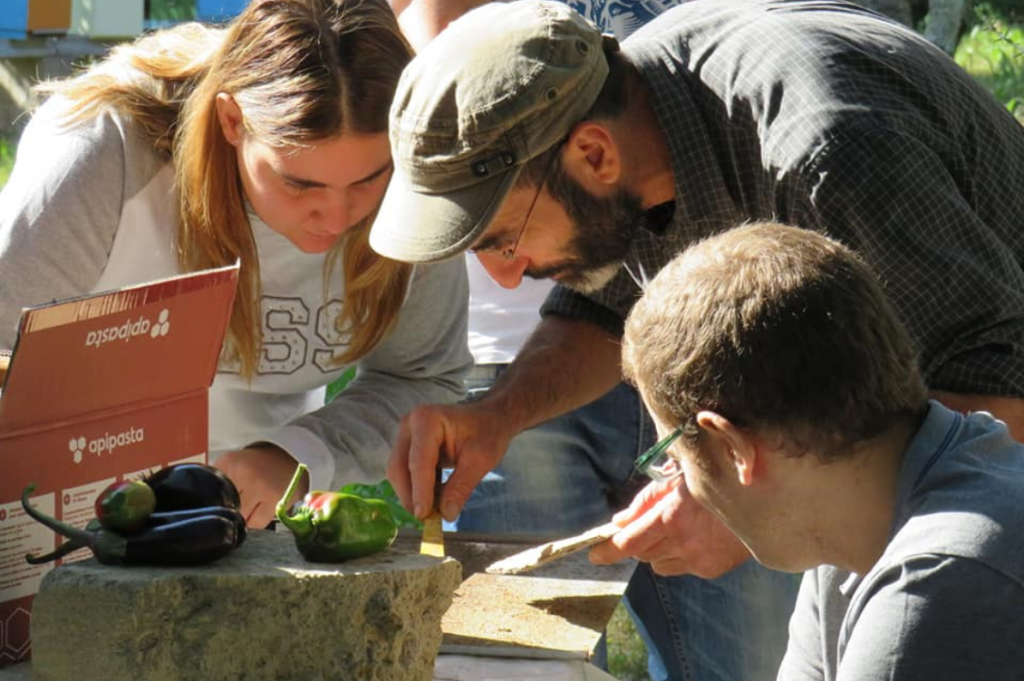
371 0 1024 681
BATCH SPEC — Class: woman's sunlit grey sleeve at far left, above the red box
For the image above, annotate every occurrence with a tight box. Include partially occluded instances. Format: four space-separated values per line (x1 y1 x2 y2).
0 102 126 349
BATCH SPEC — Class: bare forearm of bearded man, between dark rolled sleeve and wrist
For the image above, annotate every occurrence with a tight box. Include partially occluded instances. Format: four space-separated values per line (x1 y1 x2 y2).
481 315 622 431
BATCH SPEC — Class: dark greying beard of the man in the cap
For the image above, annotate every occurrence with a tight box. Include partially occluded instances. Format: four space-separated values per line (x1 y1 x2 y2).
525 161 644 293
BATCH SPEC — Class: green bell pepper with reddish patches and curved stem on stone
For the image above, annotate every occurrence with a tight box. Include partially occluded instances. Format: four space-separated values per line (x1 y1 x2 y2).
276 464 398 563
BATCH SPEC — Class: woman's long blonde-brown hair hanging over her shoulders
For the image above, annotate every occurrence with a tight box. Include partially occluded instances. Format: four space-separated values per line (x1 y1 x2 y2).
39 0 412 377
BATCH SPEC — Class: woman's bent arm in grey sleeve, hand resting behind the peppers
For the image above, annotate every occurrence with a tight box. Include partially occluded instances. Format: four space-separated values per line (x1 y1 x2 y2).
217 258 472 527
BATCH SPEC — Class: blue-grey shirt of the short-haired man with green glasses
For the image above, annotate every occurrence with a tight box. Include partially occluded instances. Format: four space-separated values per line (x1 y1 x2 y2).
778 401 1024 681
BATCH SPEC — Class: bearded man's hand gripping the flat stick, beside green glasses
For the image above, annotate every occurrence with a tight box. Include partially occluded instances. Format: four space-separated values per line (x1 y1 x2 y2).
590 478 751 580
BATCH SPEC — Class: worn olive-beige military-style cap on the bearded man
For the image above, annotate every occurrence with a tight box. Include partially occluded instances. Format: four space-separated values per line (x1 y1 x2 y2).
370 0 608 262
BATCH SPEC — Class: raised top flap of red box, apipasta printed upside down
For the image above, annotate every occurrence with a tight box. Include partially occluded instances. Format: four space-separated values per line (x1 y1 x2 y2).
0 264 239 434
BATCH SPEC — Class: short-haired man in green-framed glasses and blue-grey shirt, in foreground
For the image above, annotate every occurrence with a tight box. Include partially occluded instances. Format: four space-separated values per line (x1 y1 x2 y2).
623 223 1024 681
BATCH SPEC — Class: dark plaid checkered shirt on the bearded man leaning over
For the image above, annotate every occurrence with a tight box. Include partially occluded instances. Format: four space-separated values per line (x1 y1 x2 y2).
542 0 1024 396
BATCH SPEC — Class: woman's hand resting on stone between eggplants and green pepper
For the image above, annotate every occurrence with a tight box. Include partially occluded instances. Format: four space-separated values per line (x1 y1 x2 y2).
214 444 309 529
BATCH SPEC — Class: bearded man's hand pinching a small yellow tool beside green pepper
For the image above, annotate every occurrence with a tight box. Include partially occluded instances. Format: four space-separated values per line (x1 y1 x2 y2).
387 403 516 520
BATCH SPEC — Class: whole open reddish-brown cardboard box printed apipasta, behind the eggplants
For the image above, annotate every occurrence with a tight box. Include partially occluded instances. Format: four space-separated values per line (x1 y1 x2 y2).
0 265 238 667
